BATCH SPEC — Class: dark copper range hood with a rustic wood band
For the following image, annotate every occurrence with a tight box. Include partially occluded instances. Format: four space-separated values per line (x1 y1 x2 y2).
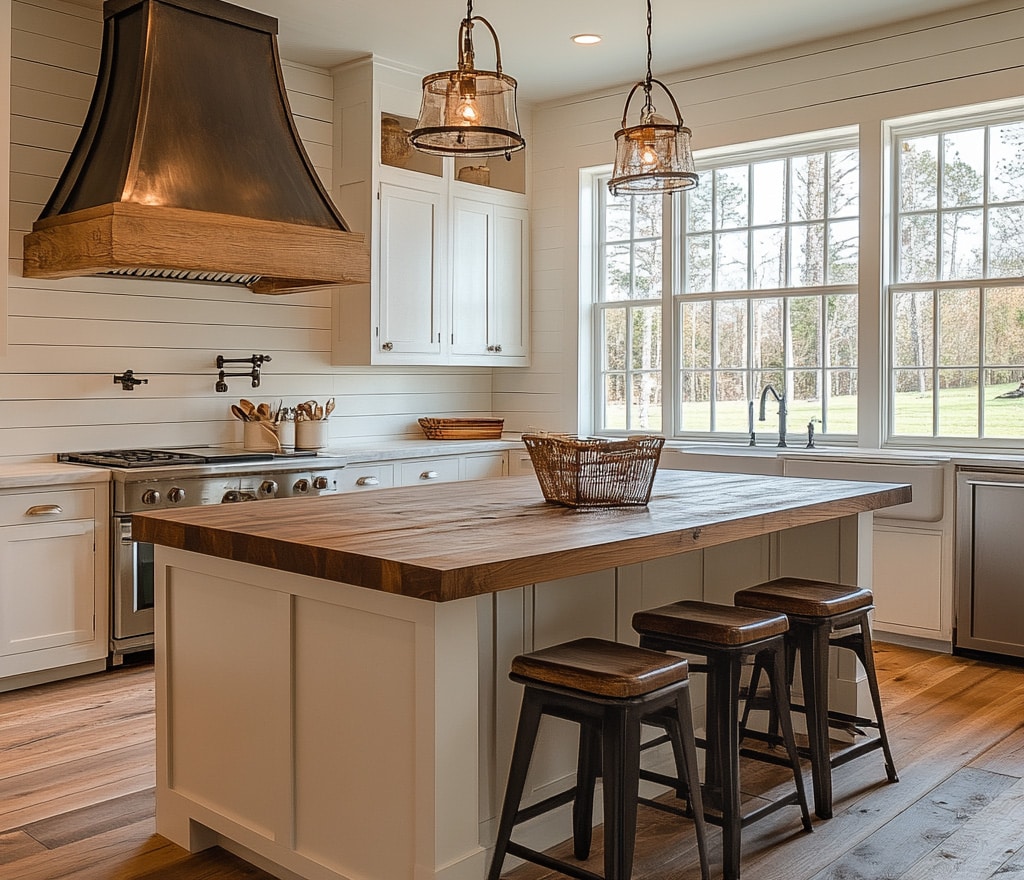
25 0 370 293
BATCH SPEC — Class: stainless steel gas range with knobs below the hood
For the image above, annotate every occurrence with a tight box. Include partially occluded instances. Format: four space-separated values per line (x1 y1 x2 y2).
57 447 345 665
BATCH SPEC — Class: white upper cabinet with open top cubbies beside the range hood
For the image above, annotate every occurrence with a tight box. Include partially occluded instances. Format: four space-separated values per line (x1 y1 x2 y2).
332 59 529 367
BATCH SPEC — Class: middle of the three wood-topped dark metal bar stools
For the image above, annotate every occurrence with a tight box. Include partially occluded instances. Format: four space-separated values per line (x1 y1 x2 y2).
633 601 811 880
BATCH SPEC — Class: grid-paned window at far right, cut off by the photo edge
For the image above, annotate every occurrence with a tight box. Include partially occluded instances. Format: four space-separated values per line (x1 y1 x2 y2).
887 109 1024 445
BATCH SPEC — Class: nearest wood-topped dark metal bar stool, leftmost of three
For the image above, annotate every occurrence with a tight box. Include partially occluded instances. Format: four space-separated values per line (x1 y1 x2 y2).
487 638 710 880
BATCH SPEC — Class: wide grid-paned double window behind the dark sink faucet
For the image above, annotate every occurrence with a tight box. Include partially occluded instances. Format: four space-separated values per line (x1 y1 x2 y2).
595 134 859 437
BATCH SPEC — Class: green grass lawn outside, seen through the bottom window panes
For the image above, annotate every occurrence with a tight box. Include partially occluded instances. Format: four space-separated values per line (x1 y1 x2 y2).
607 382 1024 439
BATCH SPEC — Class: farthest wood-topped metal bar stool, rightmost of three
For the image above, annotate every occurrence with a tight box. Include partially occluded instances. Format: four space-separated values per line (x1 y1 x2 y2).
734 578 899 819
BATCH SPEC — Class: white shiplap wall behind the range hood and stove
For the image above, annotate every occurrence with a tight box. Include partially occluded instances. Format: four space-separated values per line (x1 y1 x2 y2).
0 0 492 461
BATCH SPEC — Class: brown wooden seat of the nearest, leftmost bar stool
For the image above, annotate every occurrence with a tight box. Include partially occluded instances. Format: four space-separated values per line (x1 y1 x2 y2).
511 638 688 699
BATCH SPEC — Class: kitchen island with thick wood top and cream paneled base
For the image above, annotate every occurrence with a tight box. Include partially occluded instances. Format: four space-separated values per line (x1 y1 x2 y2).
133 471 910 880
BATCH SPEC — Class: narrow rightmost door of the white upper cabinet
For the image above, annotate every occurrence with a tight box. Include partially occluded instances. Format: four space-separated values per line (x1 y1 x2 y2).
488 205 529 358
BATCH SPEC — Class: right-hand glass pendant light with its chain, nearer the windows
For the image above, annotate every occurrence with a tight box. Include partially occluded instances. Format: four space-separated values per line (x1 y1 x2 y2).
608 0 697 196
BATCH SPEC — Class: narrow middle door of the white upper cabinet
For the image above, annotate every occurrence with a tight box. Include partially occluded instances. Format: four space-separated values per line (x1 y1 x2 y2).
452 199 493 357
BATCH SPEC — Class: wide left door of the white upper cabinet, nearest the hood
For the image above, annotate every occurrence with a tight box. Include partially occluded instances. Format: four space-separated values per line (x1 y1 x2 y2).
376 183 445 363
